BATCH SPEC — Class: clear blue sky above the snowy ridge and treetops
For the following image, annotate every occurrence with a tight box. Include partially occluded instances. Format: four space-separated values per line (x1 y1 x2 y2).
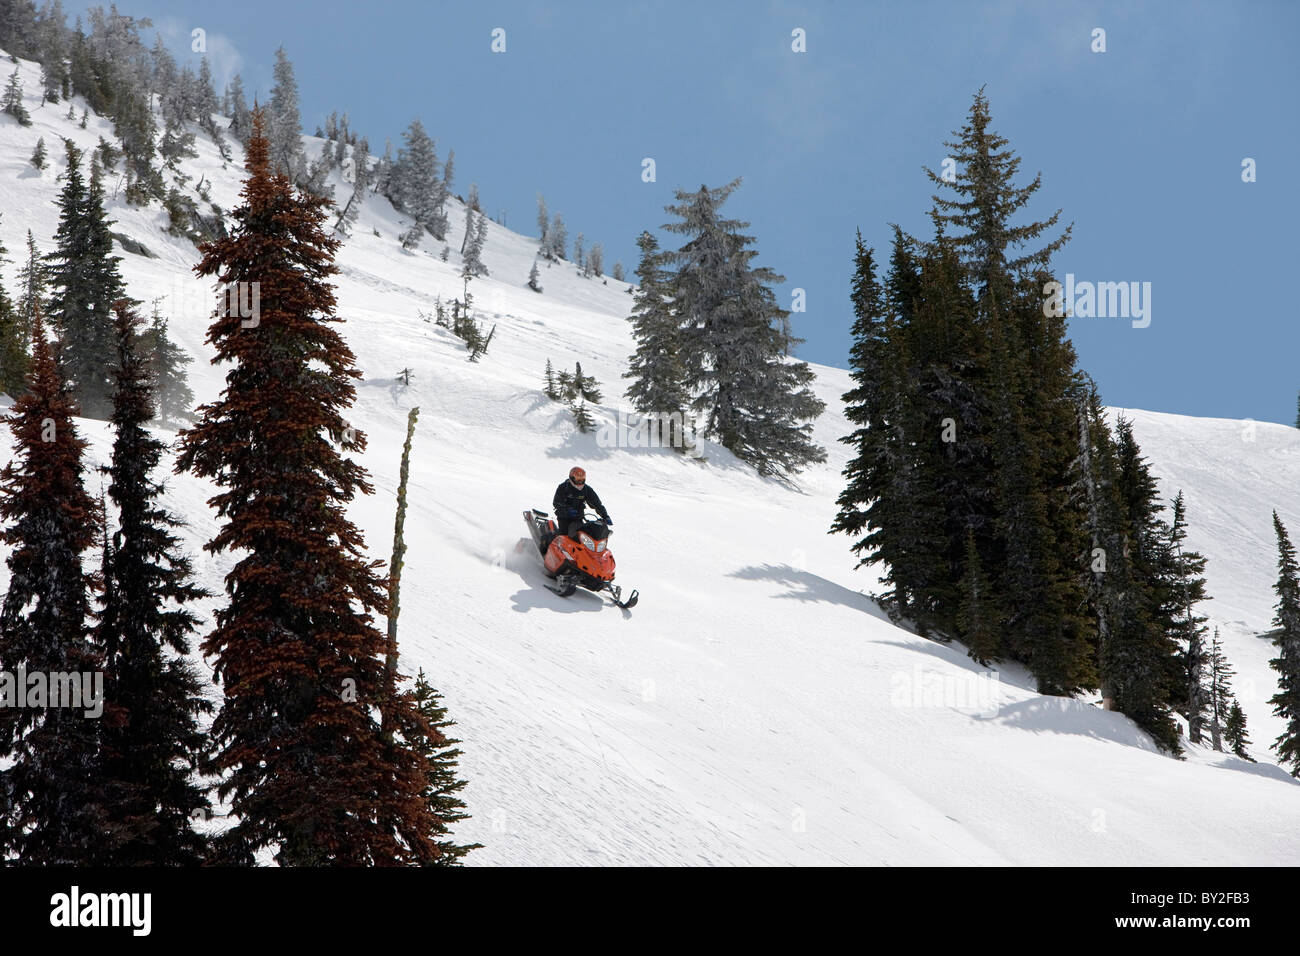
68 0 1300 424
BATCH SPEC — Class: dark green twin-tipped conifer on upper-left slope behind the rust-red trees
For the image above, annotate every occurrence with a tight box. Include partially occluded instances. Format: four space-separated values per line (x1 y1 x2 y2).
49 140 126 419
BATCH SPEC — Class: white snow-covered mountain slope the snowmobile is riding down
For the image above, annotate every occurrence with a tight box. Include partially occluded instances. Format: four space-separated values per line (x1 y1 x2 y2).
0 54 1300 865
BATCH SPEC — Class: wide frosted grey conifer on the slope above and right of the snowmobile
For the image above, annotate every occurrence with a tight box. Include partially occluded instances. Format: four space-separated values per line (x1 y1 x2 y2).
666 179 826 476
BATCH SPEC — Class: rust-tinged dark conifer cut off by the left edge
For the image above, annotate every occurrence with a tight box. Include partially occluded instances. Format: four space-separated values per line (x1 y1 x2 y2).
0 308 107 865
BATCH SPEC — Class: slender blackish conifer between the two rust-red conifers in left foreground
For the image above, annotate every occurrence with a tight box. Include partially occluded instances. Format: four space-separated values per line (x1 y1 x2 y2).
98 299 212 866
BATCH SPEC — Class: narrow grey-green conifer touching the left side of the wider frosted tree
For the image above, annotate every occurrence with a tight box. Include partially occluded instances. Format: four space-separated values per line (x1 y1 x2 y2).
623 232 690 450
